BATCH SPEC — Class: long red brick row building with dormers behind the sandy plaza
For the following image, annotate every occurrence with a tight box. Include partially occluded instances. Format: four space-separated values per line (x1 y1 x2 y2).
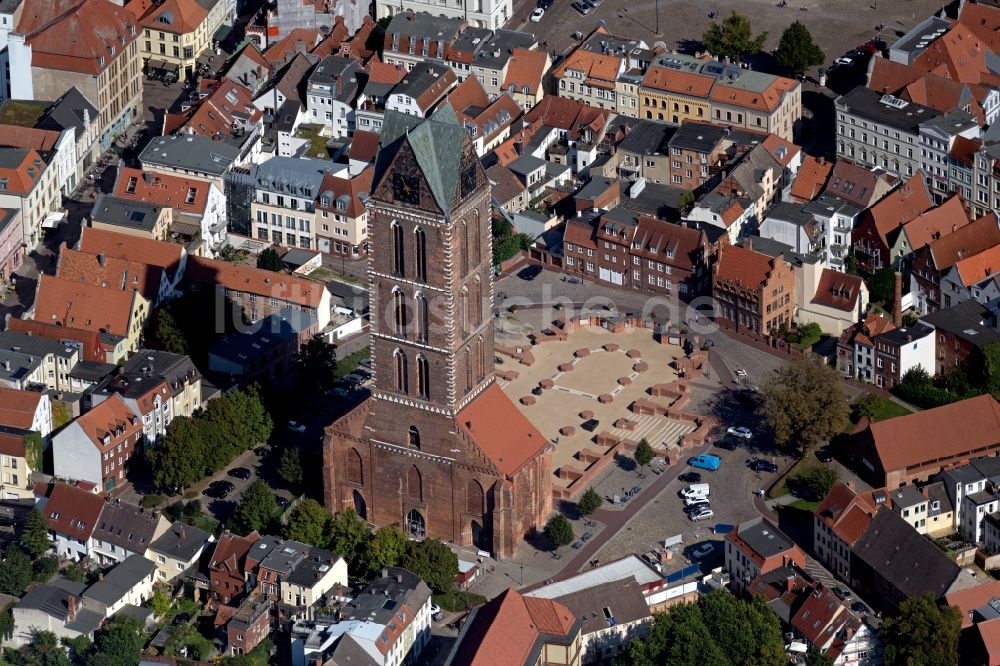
563 209 712 299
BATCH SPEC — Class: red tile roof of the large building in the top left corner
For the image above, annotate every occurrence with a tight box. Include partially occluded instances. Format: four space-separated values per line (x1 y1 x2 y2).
16 0 140 74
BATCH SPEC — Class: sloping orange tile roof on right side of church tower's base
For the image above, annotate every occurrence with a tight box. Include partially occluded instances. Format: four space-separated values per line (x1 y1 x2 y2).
455 384 548 476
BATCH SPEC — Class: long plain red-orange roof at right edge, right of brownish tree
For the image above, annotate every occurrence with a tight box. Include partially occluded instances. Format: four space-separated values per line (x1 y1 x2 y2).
865 394 1000 471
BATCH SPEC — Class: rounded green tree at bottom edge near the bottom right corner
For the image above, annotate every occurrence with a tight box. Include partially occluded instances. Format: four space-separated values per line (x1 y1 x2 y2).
879 593 962 666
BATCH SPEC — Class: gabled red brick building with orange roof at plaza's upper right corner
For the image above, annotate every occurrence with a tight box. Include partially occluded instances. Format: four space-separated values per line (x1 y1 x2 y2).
712 245 795 334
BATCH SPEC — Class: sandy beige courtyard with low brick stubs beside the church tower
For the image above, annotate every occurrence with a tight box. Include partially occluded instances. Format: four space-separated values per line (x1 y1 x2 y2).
497 318 712 499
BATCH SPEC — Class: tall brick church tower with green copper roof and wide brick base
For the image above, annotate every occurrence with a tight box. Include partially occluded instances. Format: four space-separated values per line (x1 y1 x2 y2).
323 105 552 557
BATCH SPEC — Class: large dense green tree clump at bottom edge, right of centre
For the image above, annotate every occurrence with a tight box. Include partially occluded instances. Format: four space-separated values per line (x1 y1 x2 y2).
615 590 788 666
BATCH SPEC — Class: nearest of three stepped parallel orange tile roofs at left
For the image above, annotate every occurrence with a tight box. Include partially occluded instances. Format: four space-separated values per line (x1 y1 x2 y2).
35 275 141 337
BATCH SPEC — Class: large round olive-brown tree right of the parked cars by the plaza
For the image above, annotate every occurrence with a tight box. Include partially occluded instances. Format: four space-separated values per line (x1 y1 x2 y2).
761 356 850 451
